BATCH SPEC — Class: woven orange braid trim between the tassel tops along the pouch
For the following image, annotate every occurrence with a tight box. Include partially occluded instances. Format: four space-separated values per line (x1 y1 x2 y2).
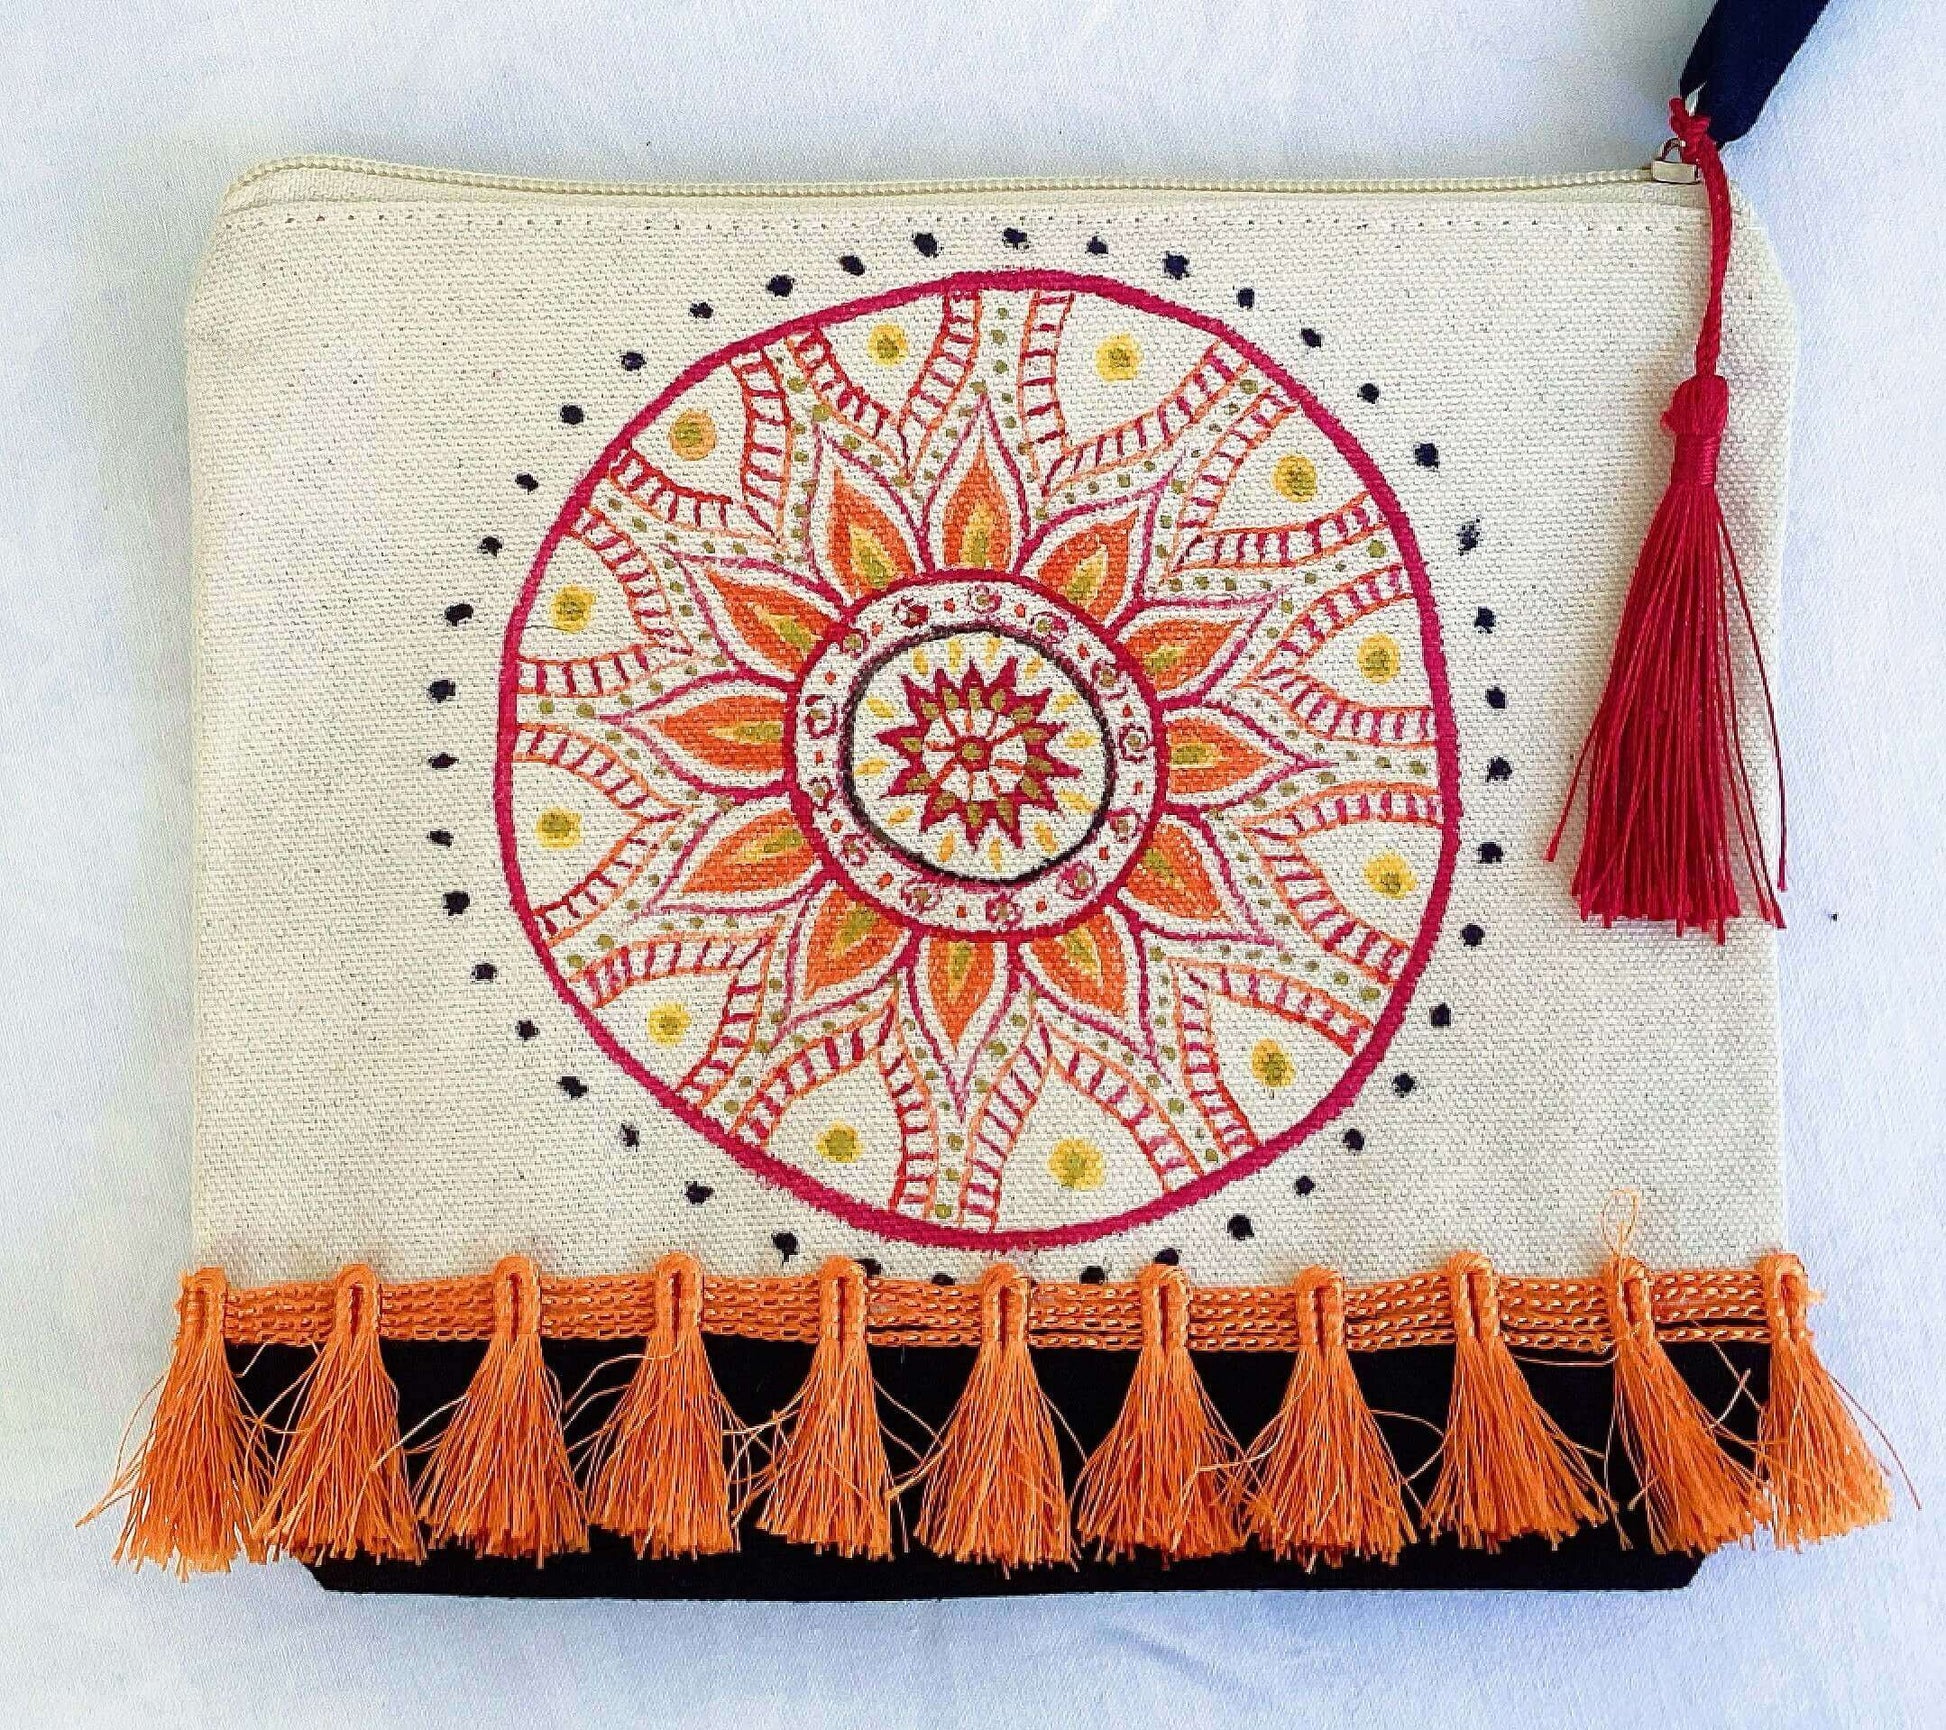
224 1267 1769 1352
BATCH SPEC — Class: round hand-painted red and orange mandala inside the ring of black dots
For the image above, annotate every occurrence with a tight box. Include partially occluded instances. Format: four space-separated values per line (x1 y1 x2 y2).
498 272 1458 1247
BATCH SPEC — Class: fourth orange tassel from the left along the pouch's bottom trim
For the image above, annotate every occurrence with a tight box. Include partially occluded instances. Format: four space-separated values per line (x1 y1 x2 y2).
588 1253 736 1561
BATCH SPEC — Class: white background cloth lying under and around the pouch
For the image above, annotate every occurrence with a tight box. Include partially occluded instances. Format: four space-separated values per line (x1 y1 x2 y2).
0 0 1946 1726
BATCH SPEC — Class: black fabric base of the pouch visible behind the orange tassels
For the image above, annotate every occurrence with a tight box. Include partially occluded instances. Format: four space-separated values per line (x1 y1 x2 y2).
232 1337 1765 1602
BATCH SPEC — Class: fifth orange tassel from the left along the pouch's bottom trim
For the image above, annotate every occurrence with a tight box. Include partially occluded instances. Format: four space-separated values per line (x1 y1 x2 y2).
757 1255 895 1559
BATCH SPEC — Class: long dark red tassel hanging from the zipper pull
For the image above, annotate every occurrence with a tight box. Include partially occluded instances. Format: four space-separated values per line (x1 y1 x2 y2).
1547 101 1784 942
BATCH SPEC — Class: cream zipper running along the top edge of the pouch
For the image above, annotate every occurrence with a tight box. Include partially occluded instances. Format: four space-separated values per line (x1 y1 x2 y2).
226 156 1693 202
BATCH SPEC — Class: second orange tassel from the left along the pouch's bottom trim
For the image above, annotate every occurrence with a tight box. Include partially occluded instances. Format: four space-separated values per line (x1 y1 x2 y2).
255 1265 426 1563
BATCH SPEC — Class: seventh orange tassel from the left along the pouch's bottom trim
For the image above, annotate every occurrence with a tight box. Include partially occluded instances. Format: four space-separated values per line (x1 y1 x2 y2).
1076 1263 1243 1559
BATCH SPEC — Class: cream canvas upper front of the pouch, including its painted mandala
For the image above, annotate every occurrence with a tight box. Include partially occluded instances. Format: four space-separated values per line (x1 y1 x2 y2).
189 165 1792 1282
